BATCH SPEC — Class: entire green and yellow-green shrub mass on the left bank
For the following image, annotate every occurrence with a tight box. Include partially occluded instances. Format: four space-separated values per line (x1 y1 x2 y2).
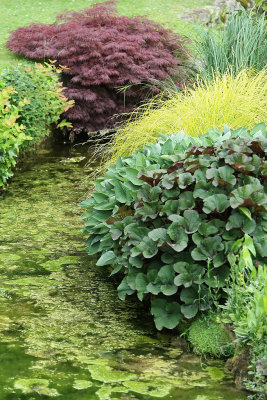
0 64 72 187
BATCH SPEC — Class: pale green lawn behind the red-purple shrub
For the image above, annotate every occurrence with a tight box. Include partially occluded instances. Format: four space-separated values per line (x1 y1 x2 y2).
0 0 213 67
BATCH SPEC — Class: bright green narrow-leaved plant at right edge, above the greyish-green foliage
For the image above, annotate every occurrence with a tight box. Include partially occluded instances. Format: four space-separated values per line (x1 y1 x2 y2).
221 235 267 346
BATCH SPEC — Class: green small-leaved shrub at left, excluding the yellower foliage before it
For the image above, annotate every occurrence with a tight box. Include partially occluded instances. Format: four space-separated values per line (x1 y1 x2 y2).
0 64 72 148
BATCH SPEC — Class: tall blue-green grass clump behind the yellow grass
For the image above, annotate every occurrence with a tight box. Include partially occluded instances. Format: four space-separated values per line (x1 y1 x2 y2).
196 10 267 80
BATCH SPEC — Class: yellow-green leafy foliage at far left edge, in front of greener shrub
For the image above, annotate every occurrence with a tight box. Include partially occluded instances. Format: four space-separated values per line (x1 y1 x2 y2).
0 82 29 187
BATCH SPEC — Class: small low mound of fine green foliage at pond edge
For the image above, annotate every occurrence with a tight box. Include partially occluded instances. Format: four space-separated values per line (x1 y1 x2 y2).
188 313 235 358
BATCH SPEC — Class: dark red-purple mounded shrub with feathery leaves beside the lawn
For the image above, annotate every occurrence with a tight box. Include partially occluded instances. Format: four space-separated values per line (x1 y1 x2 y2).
7 1 191 131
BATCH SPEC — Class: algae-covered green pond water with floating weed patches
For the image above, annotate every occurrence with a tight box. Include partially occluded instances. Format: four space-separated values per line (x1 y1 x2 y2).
0 145 249 400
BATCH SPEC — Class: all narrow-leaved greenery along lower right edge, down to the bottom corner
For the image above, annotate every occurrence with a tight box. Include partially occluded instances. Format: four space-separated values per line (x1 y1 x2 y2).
221 236 267 400
